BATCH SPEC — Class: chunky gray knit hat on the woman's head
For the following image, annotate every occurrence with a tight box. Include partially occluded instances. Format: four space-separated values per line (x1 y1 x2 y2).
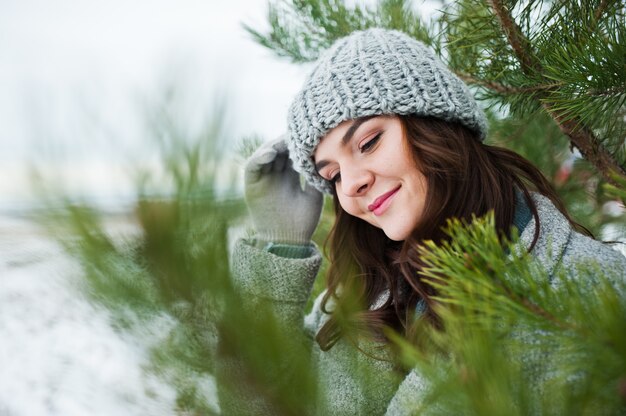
287 28 487 193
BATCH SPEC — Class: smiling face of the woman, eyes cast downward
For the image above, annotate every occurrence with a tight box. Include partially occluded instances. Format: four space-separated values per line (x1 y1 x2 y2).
313 116 428 241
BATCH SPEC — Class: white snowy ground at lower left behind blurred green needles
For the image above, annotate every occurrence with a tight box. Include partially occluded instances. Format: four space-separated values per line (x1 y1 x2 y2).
0 215 180 416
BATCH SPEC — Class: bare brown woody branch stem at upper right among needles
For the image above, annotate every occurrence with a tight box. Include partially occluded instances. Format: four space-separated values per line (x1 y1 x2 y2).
489 0 626 184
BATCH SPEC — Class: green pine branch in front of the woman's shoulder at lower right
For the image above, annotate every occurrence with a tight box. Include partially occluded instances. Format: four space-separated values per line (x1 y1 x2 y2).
402 214 626 415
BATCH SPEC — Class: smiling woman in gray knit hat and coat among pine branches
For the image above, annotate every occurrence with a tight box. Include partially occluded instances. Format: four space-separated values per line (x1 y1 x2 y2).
225 29 626 415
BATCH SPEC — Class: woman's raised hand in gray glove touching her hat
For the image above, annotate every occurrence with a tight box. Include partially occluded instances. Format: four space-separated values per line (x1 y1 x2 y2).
245 137 324 244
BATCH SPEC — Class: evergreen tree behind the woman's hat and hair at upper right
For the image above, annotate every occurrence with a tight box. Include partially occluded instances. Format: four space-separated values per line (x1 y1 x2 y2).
245 0 626 231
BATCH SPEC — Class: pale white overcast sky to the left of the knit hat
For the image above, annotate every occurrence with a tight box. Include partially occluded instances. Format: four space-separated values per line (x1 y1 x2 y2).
0 0 306 207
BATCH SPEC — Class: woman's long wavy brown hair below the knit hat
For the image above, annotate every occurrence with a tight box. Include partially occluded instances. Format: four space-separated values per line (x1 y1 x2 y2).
316 116 588 350
